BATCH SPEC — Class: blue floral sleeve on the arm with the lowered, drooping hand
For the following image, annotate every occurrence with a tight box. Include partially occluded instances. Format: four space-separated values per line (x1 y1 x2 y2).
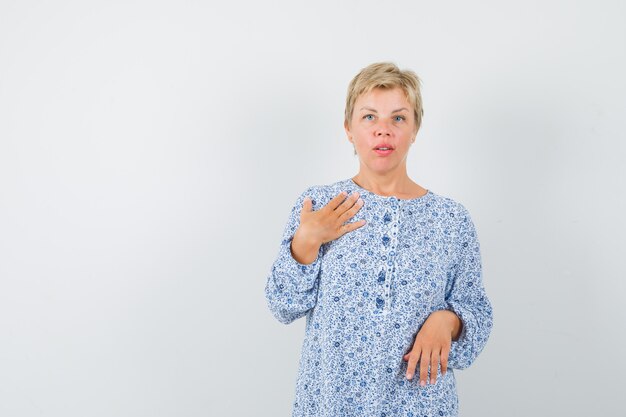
446 205 493 369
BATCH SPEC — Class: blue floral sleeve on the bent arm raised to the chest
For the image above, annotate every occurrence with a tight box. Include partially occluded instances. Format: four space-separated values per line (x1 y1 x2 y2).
265 187 324 324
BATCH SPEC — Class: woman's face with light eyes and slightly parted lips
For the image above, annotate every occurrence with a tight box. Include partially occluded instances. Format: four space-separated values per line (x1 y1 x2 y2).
344 87 417 174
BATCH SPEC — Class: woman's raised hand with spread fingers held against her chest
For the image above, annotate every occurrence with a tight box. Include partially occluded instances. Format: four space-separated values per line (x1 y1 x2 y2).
291 191 365 264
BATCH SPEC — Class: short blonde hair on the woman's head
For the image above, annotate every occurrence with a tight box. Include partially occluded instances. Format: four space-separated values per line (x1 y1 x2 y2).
344 62 424 132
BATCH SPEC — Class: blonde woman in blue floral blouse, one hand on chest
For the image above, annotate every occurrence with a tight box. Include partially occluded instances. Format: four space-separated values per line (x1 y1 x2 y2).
265 63 493 417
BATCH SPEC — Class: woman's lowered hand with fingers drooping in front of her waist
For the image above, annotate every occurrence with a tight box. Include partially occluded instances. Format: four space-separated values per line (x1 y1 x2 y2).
402 310 462 386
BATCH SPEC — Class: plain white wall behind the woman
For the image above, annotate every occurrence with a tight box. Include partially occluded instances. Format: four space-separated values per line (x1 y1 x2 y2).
0 0 626 417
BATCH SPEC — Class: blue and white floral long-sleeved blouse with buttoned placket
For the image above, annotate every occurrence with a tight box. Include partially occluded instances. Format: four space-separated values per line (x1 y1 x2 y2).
265 178 493 417
